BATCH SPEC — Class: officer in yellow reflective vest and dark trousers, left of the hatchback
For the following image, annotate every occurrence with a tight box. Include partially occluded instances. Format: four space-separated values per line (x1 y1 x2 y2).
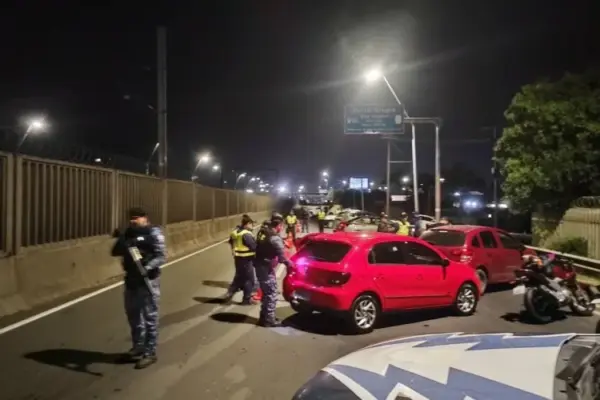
225 214 256 305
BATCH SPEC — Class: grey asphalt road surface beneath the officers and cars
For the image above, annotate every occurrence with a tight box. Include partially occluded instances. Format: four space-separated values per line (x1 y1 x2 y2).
0 227 597 400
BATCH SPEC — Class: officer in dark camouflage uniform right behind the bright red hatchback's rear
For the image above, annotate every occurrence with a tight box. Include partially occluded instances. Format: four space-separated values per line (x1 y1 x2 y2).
254 214 293 328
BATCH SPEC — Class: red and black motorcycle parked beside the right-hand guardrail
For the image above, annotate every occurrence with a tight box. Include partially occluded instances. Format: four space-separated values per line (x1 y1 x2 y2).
513 255 597 323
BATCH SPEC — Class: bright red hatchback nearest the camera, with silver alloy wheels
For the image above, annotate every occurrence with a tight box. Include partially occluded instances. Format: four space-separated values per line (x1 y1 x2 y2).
283 232 481 333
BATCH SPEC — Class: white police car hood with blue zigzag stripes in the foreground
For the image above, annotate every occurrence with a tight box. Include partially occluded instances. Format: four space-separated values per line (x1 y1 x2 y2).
323 333 576 400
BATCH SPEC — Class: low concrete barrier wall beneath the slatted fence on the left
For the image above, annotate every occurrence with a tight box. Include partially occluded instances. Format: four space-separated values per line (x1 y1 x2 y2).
0 212 270 318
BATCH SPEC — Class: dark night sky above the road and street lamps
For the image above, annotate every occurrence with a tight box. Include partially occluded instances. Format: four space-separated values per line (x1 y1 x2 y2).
0 0 600 188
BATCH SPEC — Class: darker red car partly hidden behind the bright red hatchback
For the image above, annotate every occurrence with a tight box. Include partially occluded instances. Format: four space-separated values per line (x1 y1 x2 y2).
421 225 534 290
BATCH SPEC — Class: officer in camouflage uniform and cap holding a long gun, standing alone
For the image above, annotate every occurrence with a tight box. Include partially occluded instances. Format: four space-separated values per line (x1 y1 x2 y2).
112 208 166 369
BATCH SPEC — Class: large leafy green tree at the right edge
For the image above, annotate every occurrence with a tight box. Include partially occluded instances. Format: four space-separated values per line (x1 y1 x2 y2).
496 71 600 211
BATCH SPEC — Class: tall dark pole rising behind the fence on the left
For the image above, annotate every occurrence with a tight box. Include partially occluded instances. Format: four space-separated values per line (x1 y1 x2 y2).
156 26 169 226
